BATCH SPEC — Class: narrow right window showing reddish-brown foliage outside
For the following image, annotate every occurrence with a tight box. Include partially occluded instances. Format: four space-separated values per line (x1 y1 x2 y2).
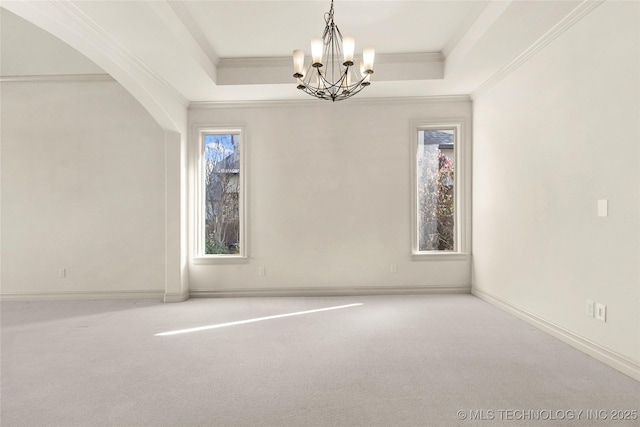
413 124 462 254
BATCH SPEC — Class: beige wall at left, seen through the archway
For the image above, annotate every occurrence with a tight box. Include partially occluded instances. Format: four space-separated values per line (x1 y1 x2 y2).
1 81 165 297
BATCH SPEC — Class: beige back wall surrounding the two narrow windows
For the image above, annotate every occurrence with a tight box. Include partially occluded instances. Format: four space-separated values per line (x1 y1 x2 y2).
189 100 471 292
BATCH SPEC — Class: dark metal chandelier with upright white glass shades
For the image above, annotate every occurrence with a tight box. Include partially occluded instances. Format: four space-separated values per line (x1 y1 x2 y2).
293 0 375 102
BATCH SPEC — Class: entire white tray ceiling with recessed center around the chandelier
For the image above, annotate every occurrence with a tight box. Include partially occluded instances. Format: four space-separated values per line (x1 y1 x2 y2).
2 0 584 103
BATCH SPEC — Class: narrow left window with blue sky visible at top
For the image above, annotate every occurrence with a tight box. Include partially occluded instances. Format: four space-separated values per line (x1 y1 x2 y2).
196 129 246 257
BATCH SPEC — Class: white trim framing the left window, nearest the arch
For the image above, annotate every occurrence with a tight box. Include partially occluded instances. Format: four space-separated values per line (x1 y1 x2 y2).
191 125 248 264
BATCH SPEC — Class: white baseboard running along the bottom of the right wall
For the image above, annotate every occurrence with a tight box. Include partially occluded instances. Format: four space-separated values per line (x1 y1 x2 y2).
471 287 640 381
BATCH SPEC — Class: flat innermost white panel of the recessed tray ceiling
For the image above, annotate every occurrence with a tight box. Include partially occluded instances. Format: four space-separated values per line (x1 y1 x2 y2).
184 0 488 58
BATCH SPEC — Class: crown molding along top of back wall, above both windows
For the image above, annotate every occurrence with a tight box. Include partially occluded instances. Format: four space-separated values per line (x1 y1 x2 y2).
189 95 471 110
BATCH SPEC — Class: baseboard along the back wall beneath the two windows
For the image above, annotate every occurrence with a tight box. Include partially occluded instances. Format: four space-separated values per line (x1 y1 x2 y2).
189 285 471 298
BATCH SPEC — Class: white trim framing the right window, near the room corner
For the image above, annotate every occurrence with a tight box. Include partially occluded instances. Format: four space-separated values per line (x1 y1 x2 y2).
410 118 471 261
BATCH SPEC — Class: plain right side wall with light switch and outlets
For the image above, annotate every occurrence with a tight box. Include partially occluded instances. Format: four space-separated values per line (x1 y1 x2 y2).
473 2 640 373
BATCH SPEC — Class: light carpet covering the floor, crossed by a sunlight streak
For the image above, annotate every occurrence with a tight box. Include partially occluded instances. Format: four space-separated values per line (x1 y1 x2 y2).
0 295 640 427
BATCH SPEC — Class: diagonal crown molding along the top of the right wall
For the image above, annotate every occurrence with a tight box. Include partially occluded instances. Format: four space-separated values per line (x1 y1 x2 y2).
471 0 605 100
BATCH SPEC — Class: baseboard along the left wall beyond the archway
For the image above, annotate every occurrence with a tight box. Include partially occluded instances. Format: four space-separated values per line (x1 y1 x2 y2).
0 291 164 301
